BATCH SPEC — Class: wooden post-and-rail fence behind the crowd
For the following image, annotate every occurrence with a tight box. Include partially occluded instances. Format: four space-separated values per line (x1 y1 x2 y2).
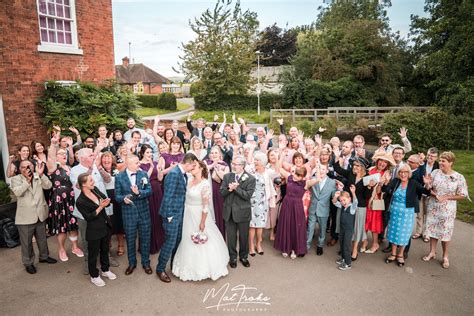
270 106 430 123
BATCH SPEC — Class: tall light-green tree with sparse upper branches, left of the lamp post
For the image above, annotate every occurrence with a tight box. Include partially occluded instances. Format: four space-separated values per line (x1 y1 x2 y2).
180 0 258 101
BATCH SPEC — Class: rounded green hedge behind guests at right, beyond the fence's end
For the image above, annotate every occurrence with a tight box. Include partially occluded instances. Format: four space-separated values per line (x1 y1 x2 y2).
382 107 474 152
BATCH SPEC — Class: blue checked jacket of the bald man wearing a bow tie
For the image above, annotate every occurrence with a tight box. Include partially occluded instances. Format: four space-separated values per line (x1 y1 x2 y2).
115 169 153 212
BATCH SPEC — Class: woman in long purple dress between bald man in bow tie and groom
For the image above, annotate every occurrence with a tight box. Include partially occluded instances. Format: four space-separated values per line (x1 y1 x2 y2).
140 144 165 254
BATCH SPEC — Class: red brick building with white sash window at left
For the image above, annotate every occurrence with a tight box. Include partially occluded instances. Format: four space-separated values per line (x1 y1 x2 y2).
0 0 115 179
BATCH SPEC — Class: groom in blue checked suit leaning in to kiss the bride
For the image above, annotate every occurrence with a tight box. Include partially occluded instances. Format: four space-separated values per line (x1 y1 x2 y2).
156 153 198 283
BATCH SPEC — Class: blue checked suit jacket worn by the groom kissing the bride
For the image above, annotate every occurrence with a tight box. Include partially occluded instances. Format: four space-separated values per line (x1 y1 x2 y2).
160 166 186 217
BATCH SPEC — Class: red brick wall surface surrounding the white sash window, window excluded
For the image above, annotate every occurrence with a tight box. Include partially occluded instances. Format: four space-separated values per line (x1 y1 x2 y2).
0 0 115 153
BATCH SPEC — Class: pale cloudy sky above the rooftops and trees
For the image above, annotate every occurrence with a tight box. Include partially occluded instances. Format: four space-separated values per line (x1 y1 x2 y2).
112 0 425 77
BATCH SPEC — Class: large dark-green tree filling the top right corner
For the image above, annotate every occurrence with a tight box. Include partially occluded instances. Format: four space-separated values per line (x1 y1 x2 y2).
411 0 474 114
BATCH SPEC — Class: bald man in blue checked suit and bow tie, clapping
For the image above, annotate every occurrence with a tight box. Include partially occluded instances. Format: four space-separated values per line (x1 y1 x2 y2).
115 155 153 275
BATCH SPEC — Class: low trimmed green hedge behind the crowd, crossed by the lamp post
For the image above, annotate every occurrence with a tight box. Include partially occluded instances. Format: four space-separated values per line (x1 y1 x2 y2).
194 93 281 111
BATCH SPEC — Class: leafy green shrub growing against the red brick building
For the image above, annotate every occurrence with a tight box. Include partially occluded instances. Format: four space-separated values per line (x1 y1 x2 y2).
37 81 140 137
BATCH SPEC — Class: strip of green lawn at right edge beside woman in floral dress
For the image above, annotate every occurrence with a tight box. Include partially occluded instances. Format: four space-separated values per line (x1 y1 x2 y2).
454 150 474 224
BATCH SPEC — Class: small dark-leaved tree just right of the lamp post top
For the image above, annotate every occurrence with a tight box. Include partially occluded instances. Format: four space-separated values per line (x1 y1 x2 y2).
257 23 298 66
